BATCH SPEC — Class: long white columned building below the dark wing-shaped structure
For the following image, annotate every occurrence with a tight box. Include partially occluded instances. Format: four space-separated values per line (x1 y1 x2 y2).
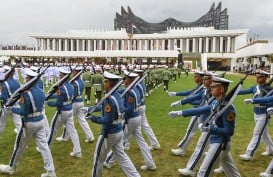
0 27 273 70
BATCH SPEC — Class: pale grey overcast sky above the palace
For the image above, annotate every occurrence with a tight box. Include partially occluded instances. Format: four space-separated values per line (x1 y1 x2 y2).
0 0 273 45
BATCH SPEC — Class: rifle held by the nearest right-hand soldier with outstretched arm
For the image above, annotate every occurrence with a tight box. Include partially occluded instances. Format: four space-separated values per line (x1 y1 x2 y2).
203 72 251 127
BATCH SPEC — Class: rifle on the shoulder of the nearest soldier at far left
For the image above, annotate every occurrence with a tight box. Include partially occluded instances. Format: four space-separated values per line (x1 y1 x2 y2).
5 65 49 107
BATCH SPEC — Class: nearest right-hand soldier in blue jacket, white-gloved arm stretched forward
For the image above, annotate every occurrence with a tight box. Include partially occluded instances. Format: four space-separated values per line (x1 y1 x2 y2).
169 77 240 177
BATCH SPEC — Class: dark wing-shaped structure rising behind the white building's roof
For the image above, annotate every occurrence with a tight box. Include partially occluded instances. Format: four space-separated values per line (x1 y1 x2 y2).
114 2 228 34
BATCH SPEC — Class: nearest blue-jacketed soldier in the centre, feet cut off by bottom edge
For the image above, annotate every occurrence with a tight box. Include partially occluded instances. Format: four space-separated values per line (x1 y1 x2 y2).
85 71 140 177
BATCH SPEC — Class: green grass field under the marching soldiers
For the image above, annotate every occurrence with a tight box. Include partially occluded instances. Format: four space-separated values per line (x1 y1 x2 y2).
0 74 273 177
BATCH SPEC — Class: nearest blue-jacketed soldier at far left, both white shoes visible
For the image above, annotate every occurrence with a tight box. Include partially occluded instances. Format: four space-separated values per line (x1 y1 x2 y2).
0 69 56 177
